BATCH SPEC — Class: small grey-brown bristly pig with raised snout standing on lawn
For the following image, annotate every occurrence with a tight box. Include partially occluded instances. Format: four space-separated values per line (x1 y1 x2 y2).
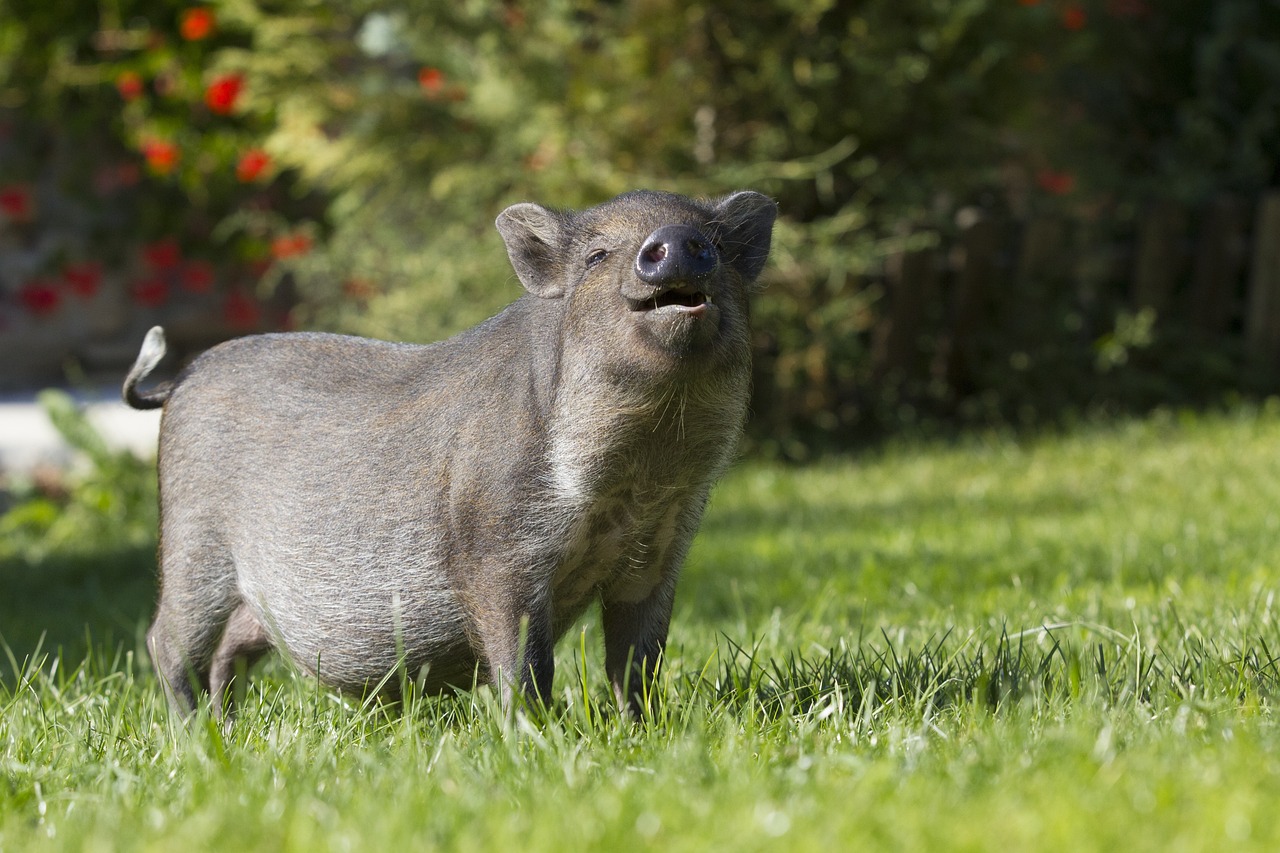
123 191 777 720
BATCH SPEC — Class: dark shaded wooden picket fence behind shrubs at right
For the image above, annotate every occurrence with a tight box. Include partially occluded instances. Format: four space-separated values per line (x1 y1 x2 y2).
872 190 1280 387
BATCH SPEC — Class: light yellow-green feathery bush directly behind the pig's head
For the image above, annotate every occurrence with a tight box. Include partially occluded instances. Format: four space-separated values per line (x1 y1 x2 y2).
259 1 1059 345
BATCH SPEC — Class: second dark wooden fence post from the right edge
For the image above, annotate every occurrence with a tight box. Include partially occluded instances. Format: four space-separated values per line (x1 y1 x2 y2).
1187 195 1248 337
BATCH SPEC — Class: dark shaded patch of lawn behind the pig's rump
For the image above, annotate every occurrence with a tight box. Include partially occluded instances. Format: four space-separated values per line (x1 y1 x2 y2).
0 546 155 686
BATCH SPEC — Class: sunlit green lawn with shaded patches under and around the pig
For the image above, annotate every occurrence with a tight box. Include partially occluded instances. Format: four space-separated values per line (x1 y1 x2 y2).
0 409 1280 852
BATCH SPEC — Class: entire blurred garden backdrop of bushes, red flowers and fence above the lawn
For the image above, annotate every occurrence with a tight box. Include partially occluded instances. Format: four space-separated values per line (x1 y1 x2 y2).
0 0 1280 460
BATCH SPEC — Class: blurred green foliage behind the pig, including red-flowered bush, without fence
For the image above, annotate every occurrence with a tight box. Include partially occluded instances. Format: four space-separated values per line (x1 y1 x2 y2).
0 0 1280 456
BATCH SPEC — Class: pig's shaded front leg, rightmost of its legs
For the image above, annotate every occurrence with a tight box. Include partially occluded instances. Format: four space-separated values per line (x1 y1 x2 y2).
600 571 678 719
